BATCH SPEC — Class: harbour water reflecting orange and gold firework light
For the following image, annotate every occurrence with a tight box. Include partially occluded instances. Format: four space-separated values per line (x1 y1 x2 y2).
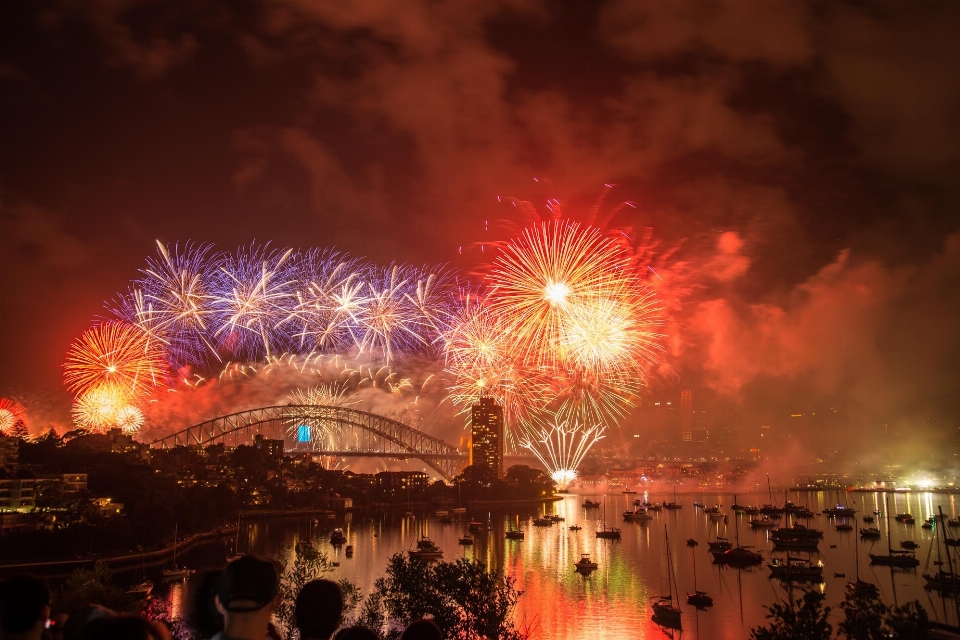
158 492 960 640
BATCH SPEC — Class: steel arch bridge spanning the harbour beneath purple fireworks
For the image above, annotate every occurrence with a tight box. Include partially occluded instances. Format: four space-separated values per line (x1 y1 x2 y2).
144 404 466 480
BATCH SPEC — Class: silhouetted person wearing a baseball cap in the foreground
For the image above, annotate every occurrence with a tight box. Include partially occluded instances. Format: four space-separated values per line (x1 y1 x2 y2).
213 556 280 640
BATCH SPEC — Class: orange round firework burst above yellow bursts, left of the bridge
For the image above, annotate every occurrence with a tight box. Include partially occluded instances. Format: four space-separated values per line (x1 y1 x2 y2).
63 322 167 397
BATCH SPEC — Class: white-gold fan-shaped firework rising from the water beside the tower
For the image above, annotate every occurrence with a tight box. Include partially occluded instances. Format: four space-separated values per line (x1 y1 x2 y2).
521 419 606 491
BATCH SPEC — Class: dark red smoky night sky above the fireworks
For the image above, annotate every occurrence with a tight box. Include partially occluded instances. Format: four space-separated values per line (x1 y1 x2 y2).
0 0 960 444
